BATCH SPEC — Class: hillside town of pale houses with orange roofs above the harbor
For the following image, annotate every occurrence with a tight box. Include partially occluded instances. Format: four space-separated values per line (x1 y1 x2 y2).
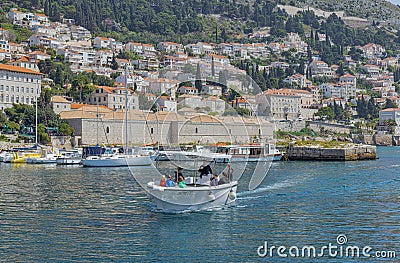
0 9 400 144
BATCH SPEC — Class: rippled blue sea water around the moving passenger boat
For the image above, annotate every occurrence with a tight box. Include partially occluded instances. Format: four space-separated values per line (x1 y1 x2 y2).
0 147 400 262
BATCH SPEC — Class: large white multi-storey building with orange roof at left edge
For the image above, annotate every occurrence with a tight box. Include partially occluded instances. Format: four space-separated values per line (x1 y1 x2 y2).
0 64 42 109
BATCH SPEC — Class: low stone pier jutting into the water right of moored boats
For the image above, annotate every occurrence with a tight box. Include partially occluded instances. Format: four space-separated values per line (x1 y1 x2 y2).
286 145 376 161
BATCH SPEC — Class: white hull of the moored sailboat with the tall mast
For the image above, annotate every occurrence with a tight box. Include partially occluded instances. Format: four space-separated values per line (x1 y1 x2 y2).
82 155 152 167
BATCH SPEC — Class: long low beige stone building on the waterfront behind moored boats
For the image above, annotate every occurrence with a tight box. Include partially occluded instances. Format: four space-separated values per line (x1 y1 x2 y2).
60 107 274 145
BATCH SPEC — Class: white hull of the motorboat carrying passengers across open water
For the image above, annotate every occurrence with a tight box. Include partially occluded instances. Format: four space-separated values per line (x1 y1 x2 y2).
147 177 237 213
